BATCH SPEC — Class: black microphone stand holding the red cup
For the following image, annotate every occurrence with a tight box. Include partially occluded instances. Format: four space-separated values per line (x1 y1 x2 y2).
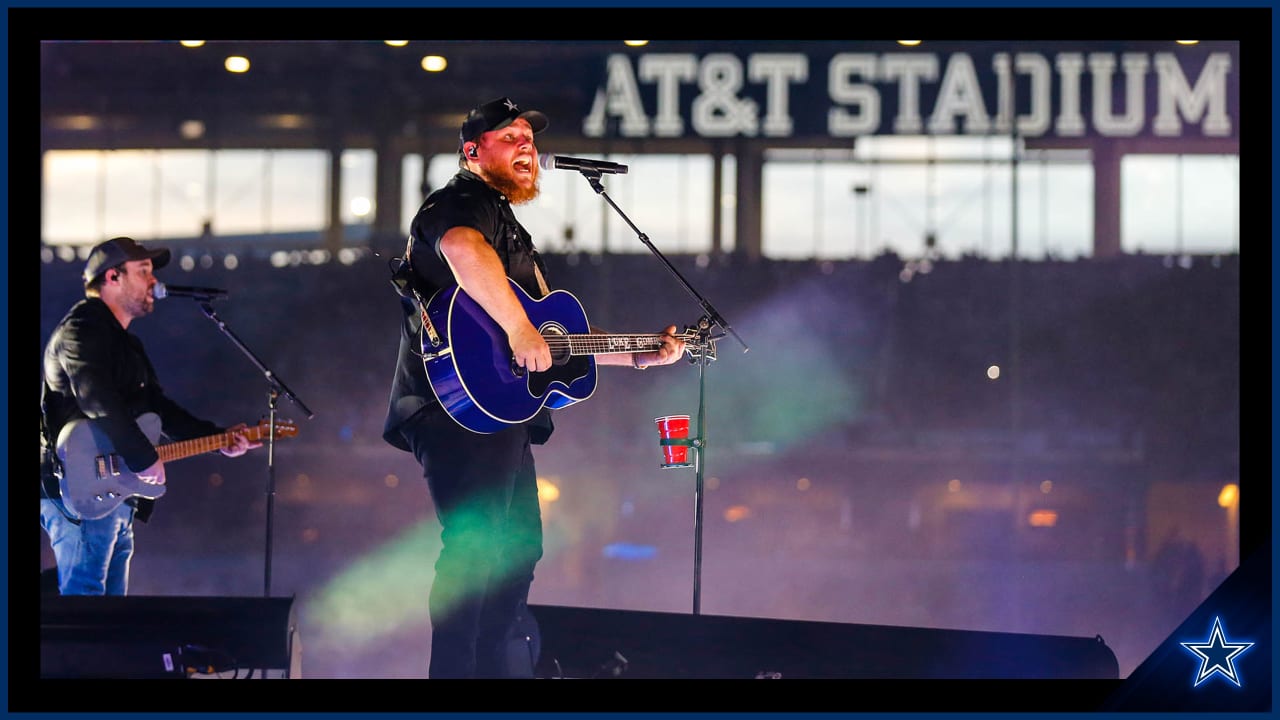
579 168 750 615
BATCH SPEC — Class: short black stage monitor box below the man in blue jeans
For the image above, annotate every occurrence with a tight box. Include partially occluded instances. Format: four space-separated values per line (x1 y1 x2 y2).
40 596 302 679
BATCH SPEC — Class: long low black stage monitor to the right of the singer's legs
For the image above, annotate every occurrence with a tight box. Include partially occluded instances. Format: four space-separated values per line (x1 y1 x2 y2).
529 605 1120 679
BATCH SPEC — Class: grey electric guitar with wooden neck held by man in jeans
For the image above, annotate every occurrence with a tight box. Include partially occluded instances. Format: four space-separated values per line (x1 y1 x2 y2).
56 413 298 520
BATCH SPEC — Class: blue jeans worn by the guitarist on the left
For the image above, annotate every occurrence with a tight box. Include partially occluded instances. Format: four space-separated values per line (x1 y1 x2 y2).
40 498 134 594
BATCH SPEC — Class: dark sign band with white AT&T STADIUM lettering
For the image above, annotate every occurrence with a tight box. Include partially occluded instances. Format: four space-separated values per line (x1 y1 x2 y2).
582 50 1239 138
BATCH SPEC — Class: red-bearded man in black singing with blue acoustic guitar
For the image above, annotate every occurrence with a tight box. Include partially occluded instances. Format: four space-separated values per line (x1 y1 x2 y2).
384 97 685 678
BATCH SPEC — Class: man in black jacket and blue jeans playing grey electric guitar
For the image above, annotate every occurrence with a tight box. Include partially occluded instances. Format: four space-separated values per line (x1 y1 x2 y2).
40 237 262 594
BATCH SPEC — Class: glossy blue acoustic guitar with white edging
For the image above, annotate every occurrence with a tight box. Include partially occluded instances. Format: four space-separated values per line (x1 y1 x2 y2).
421 278 695 434
